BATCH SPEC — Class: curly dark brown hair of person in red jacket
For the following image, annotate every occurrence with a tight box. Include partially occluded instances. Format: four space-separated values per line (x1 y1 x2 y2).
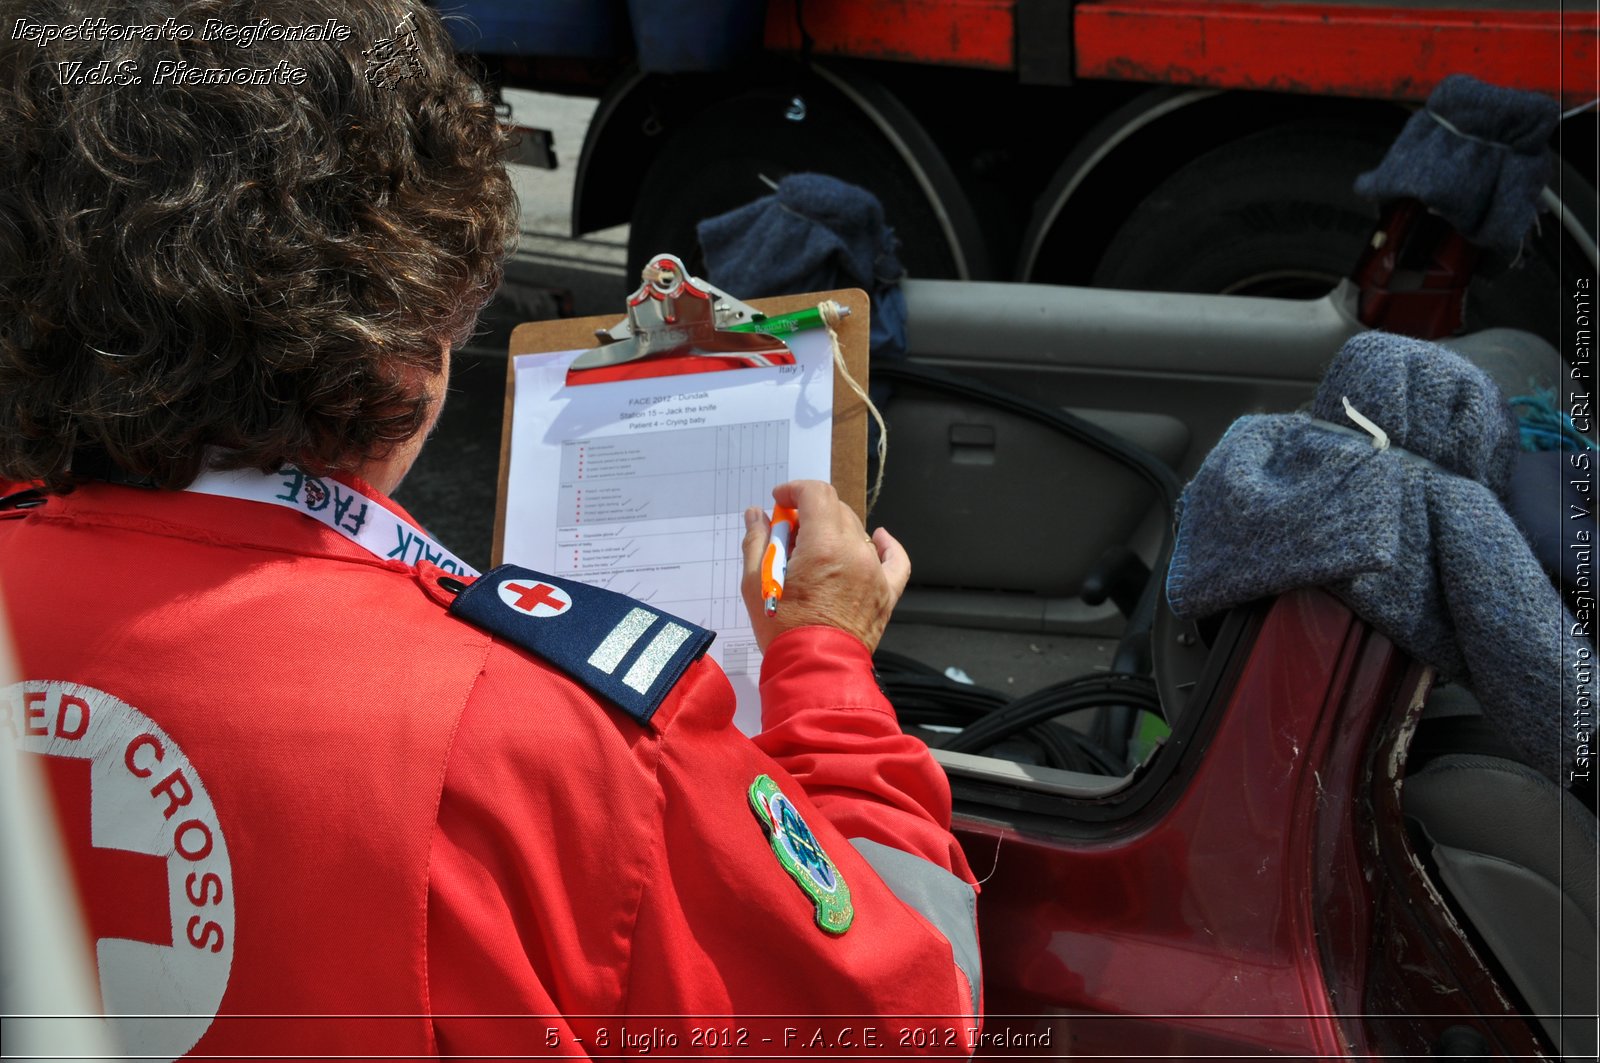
0 0 517 490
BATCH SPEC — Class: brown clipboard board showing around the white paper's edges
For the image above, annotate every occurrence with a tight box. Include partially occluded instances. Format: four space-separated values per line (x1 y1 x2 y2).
491 288 870 565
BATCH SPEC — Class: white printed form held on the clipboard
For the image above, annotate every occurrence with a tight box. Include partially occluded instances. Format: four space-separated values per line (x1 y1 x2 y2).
502 330 834 735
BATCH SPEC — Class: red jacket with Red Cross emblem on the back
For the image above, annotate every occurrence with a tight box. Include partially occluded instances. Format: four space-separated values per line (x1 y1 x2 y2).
0 485 976 1057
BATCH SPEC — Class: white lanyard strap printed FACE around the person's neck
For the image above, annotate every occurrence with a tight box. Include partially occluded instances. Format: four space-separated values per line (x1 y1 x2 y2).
186 464 478 576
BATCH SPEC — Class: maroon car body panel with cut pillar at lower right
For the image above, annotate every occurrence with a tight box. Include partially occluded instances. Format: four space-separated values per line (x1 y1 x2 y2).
957 591 1541 1058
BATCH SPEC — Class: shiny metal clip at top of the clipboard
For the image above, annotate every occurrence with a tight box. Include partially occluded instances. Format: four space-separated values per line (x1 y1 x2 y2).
566 255 795 384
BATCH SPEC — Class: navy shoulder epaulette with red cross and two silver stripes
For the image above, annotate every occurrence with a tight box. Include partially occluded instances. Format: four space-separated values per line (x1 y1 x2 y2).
450 565 717 724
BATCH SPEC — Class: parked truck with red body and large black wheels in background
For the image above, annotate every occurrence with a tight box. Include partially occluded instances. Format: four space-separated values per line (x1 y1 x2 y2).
461 0 1600 341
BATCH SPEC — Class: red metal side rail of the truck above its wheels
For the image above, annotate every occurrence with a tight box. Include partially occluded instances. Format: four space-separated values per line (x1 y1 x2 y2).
765 0 1600 104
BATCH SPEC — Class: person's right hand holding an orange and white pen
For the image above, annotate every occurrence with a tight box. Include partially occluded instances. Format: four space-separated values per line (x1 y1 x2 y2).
741 480 910 653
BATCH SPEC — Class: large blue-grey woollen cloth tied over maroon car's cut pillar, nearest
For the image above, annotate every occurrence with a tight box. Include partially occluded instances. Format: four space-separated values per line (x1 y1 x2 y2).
1166 333 1595 783
